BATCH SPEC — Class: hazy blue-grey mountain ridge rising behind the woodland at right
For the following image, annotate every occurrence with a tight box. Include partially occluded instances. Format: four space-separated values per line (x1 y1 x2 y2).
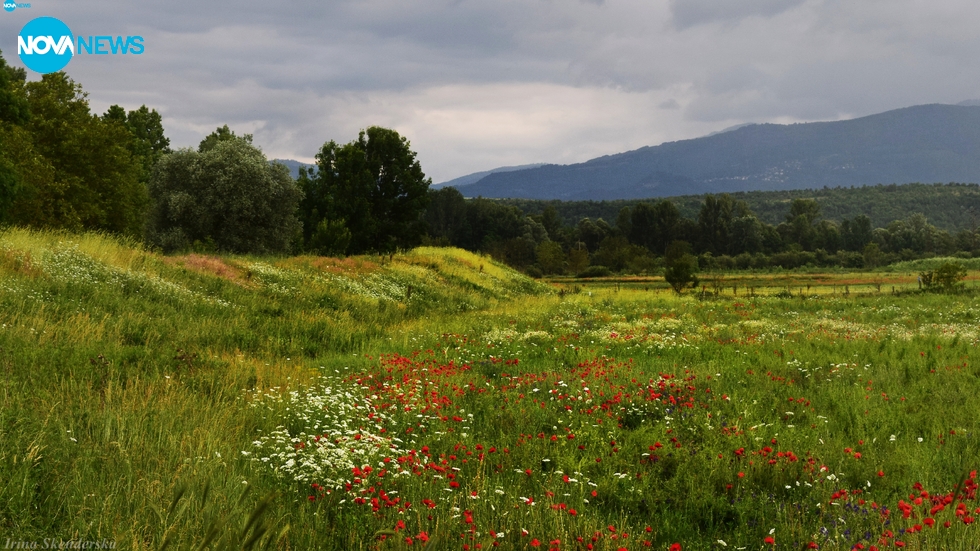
447 102 980 201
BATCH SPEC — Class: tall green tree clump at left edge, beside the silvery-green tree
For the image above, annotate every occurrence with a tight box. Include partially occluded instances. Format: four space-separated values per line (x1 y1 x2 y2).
0 49 166 236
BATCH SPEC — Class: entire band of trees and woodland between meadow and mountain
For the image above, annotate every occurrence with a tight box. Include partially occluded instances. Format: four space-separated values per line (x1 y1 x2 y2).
0 49 980 281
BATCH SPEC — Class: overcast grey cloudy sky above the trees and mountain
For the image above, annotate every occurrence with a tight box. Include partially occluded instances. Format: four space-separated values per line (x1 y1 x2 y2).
0 0 980 183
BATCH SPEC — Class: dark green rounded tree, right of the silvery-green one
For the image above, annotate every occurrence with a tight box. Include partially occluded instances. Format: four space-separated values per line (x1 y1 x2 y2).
299 126 432 254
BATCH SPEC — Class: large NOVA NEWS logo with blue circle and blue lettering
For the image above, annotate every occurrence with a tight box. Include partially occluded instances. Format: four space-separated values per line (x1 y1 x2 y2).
17 17 144 75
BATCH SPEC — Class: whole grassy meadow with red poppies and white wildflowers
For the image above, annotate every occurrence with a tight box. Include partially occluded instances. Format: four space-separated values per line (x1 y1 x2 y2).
0 230 980 550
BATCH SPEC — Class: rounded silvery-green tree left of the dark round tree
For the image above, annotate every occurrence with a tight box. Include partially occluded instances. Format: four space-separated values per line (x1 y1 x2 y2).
147 139 302 253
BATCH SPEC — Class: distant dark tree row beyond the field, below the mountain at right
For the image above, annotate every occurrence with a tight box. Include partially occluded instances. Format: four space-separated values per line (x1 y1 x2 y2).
426 188 980 275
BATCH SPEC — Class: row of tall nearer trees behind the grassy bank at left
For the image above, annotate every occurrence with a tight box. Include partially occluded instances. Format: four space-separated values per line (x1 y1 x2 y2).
0 51 431 255
